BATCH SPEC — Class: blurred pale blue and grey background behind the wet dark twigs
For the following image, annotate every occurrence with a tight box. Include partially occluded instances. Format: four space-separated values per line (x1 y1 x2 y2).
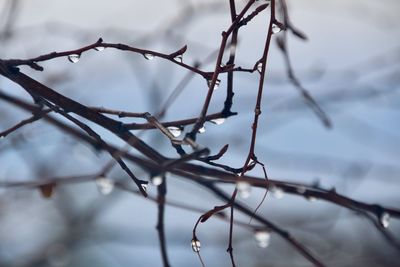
0 0 400 267
